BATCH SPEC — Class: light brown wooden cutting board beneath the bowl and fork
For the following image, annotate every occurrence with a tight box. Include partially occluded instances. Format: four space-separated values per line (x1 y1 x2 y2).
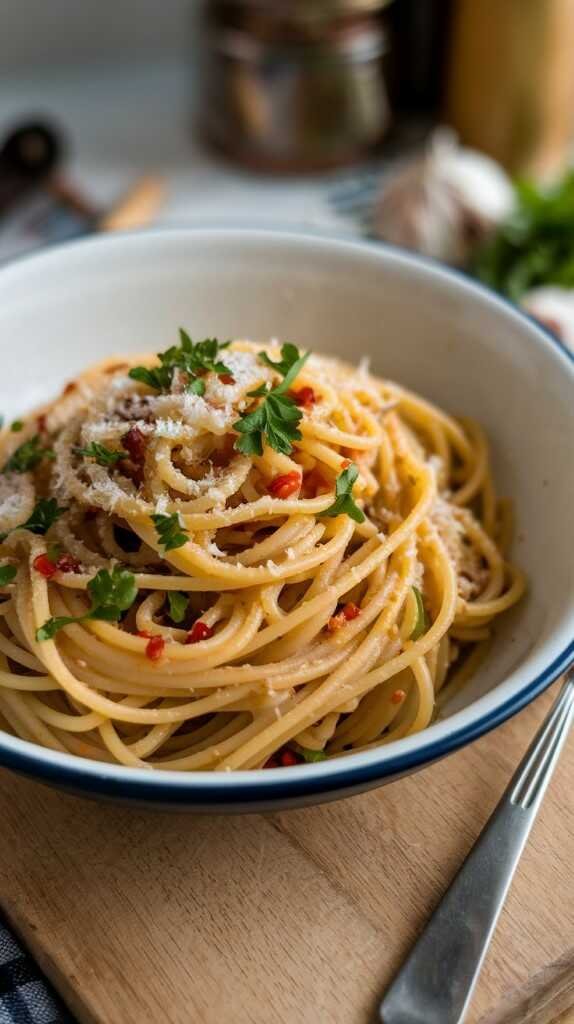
0 687 574 1024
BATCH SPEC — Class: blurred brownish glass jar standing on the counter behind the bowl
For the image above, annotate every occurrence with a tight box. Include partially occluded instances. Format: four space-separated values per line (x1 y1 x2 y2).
201 0 390 172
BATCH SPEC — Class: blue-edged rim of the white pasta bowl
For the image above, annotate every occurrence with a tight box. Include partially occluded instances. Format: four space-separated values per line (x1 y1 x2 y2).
0 225 574 809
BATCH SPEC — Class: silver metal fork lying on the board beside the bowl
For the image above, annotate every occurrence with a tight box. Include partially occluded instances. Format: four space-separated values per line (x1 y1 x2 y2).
380 669 574 1024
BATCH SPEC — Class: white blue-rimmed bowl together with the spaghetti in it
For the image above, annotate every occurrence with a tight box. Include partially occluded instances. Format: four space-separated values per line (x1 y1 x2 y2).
0 230 574 811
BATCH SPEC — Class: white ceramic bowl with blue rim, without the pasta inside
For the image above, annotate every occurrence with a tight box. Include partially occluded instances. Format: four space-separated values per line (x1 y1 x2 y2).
0 230 574 810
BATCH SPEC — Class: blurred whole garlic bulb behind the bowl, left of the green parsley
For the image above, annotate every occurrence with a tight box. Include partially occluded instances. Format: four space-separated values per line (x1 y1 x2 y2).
373 129 515 266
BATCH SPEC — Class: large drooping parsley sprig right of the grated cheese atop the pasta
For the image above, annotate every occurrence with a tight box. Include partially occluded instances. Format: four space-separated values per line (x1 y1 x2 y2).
233 345 310 455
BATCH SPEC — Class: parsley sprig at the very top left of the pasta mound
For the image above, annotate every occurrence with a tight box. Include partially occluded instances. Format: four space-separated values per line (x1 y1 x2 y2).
129 328 230 395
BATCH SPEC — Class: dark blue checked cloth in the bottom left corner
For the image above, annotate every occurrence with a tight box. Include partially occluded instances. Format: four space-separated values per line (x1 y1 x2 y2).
0 915 74 1024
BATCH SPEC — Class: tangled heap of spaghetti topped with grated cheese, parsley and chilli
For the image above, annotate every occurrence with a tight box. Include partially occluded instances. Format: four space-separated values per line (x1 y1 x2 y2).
0 332 524 771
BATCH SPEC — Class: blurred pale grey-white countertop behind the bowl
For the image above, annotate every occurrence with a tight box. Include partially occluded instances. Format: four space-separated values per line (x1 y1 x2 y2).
0 60 379 237
